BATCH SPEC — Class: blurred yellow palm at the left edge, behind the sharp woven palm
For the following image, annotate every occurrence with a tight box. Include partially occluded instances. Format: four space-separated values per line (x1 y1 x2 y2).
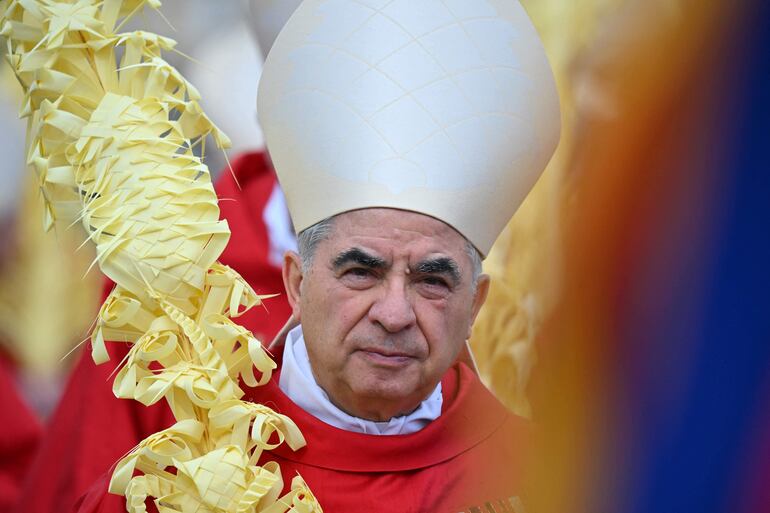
0 66 101 381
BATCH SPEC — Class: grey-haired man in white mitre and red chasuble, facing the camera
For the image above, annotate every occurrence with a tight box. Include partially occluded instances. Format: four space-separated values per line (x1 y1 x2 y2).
73 0 559 513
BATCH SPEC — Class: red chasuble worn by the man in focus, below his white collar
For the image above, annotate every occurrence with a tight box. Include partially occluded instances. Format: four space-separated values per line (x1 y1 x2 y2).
72 363 530 513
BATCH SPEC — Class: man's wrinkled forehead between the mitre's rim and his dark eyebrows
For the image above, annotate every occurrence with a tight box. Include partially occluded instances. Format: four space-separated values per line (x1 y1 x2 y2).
320 208 468 263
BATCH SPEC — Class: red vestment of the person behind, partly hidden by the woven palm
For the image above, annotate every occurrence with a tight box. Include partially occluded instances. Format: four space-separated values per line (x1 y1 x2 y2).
16 153 291 513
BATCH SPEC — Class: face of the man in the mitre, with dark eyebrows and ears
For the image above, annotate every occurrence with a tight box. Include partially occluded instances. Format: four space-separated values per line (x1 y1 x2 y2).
284 208 488 421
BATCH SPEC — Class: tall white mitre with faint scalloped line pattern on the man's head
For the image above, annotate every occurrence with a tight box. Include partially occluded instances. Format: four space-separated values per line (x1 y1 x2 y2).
258 0 560 255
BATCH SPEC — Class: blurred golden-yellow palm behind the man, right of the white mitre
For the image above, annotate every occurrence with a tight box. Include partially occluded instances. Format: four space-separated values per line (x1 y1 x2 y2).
470 0 628 417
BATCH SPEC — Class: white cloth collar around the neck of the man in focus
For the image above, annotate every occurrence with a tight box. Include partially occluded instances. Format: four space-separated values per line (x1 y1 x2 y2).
278 326 444 435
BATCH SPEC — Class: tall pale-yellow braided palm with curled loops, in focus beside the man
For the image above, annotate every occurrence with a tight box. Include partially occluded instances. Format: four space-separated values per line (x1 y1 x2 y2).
0 0 321 513
